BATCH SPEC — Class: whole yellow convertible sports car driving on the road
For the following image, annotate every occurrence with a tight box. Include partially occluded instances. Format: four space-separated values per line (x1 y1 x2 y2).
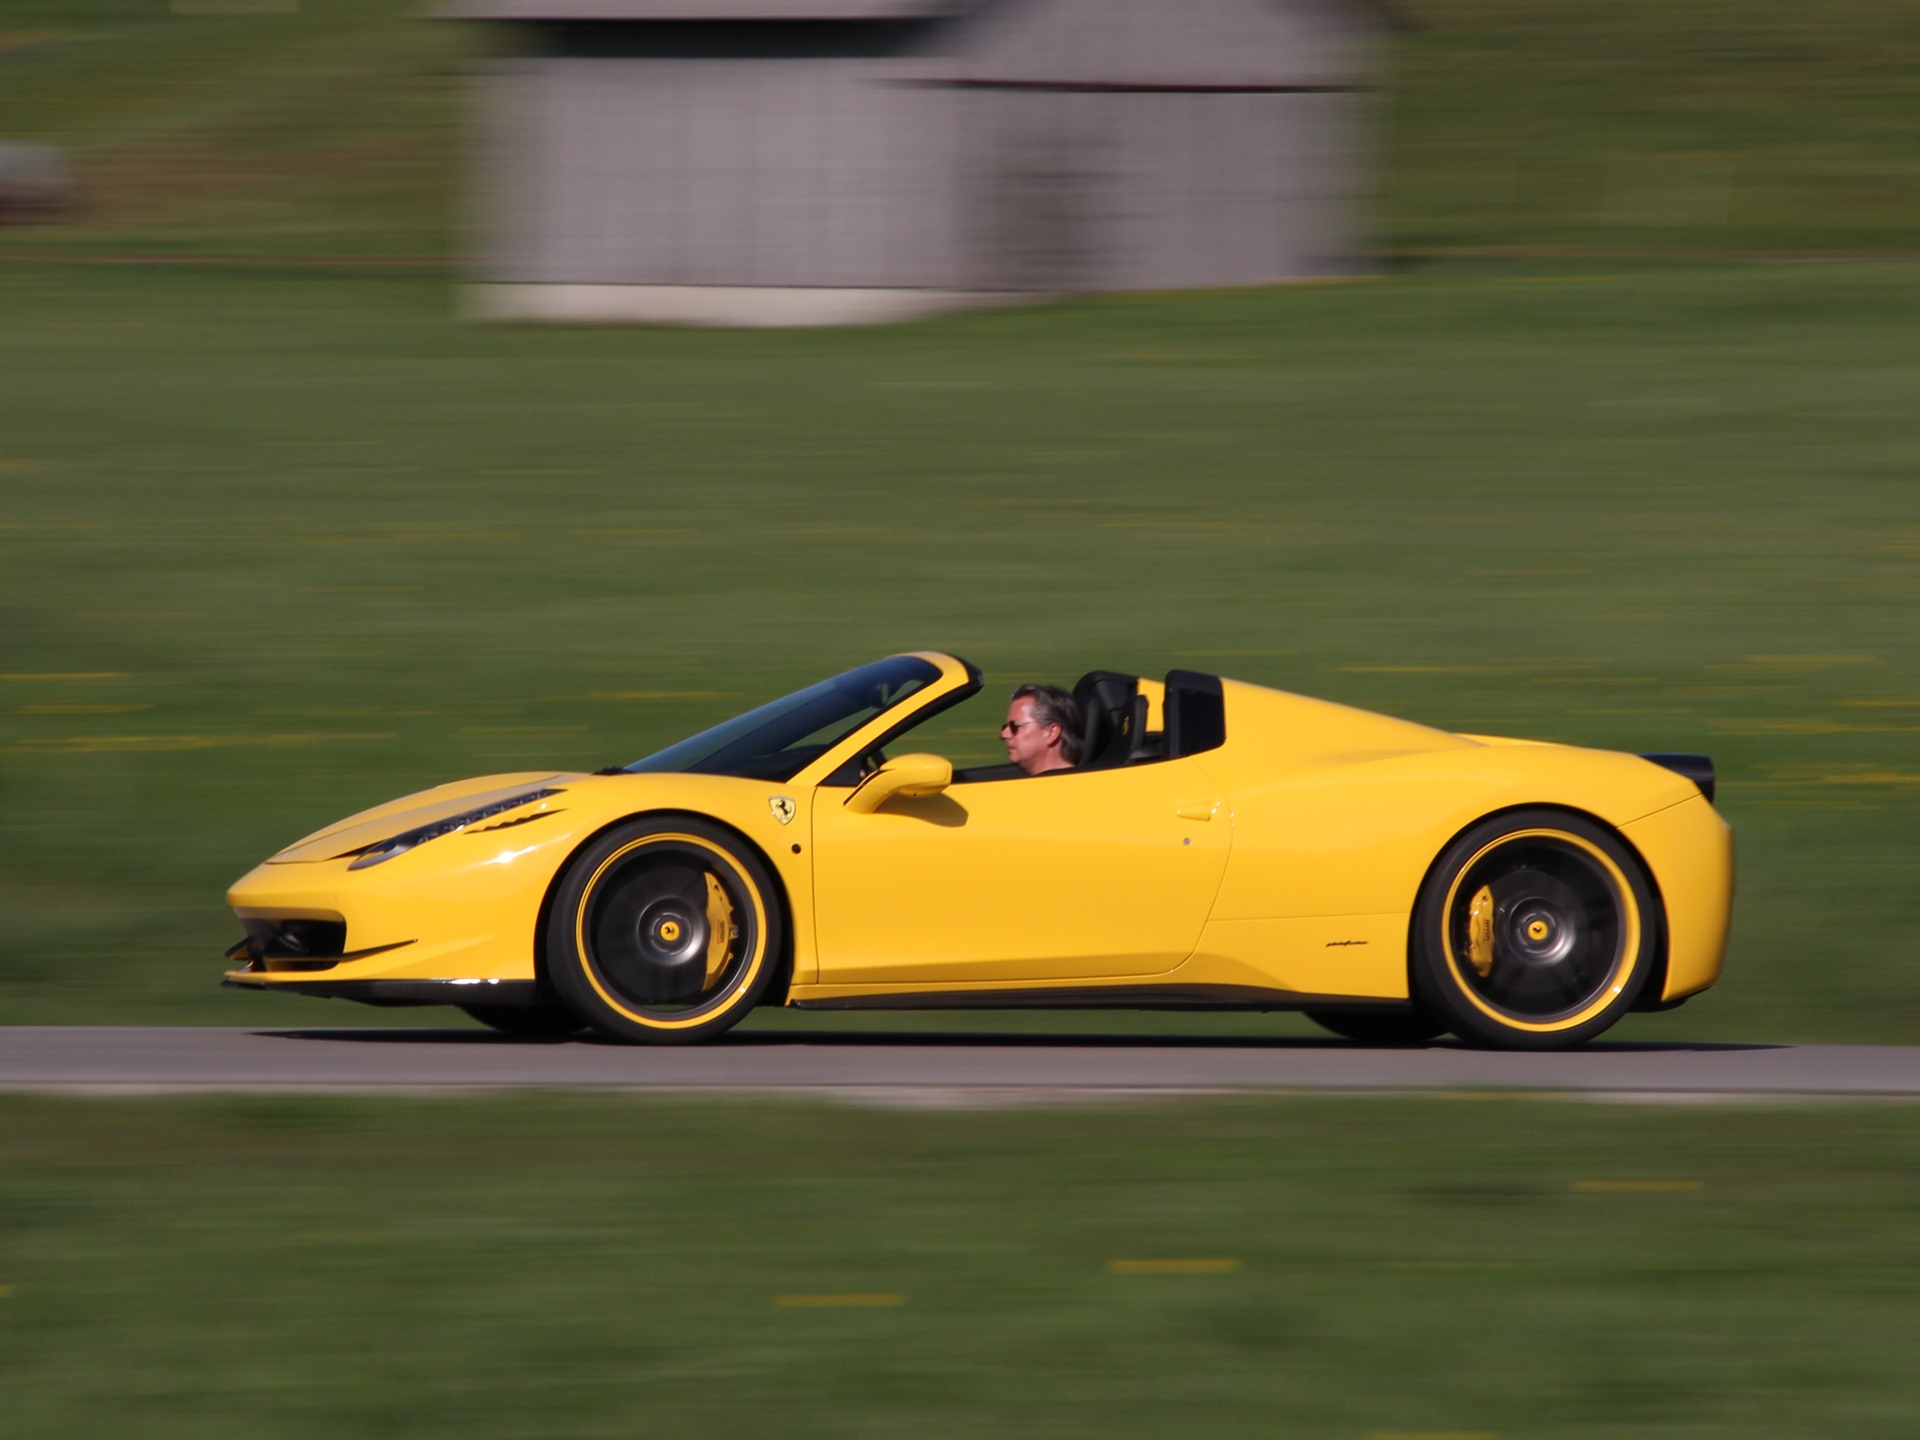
225 651 1734 1048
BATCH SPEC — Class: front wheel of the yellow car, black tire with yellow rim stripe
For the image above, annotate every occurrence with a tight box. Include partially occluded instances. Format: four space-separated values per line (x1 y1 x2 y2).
547 816 785 1044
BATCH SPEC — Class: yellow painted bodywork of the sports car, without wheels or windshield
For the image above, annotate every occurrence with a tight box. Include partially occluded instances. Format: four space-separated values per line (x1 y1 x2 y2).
227 651 1732 1029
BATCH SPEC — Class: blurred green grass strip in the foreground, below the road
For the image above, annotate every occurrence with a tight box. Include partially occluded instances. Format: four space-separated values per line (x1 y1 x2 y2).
0 1096 1920 1440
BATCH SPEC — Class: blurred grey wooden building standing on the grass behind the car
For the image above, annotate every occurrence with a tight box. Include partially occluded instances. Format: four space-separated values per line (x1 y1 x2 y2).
444 0 1375 324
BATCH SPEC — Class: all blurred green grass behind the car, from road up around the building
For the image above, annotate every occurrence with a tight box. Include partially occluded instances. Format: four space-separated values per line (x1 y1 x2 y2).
0 0 1920 1041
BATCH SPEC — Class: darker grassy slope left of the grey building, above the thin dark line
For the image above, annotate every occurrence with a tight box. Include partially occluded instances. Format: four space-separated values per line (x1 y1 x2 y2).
0 0 455 259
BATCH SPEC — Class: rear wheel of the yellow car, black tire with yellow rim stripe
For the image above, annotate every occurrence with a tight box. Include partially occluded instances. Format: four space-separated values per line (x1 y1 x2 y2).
1411 810 1661 1050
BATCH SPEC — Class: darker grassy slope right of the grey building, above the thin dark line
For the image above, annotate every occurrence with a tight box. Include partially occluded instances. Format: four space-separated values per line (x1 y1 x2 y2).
1382 0 1920 253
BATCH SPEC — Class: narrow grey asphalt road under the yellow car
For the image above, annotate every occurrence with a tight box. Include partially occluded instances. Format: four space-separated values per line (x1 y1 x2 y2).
0 1025 1920 1104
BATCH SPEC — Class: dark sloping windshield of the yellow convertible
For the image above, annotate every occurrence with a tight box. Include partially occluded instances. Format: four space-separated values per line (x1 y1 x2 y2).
628 655 941 780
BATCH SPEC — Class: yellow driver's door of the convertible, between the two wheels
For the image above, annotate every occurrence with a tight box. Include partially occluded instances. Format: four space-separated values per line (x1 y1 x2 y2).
814 758 1231 985
